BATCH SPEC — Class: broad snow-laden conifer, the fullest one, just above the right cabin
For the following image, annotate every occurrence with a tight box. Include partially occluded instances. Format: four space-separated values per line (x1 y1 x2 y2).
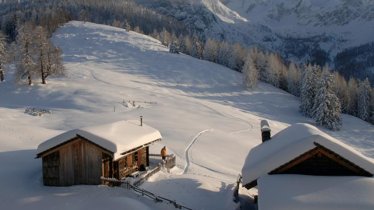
313 72 342 130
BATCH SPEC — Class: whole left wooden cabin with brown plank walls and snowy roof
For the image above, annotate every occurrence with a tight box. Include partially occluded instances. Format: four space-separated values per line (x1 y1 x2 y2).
37 121 162 186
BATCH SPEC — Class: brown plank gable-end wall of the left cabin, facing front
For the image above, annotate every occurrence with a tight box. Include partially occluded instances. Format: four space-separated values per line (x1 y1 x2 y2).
42 137 112 186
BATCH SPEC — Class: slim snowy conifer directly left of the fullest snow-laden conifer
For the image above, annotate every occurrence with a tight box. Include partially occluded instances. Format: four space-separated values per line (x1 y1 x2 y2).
300 64 320 117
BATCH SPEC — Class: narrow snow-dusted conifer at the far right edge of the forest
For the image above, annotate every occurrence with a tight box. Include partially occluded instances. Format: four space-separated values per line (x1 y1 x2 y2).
357 78 371 121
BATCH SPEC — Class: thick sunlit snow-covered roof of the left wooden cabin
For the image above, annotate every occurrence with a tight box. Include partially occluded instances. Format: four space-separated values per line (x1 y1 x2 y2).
36 121 162 159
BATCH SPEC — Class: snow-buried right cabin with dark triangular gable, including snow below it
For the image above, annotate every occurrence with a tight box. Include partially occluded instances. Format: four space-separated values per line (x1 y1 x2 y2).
242 124 374 210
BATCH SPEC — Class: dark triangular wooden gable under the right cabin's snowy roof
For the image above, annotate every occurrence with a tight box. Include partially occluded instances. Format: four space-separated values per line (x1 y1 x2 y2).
269 143 373 177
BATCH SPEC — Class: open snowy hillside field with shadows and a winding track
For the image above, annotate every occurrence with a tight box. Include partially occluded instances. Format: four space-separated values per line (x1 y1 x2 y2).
0 22 374 210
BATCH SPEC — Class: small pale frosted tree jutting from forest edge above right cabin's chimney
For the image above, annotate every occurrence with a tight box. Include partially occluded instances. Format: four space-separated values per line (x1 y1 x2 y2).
242 54 259 88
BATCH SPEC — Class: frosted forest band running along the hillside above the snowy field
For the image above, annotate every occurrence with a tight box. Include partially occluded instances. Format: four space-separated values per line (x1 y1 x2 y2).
0 0 374 126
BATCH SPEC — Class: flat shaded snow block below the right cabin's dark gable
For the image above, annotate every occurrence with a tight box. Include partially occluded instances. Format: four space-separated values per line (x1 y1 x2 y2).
258 175 374 210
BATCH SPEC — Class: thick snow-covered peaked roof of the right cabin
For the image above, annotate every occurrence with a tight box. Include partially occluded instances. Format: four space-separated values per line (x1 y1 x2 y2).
242 123 374 185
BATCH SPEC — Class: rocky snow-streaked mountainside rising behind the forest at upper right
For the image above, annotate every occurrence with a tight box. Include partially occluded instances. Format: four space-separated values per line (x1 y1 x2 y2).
136 0 374 81
